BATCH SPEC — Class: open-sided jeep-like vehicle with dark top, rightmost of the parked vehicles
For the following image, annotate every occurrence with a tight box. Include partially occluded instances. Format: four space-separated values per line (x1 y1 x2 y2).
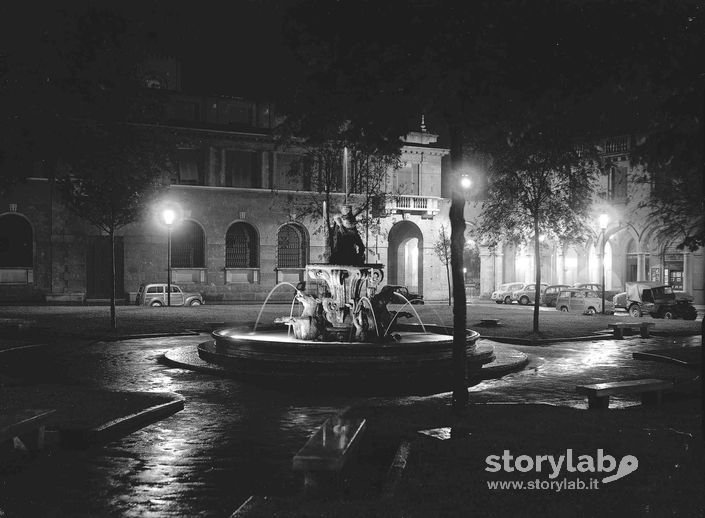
613 282 698 320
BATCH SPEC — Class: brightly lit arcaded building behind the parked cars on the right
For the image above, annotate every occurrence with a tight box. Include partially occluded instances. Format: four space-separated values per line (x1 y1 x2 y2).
467 136 705 304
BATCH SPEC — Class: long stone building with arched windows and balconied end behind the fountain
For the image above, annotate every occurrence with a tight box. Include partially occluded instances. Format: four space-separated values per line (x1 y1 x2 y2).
0 63 448 303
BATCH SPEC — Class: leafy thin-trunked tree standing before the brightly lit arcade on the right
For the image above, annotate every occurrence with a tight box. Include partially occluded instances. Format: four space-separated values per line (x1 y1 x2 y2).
480 128 597 333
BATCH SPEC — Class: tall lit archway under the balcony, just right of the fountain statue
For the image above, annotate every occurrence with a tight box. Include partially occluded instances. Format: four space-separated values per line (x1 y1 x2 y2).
387 221 423 294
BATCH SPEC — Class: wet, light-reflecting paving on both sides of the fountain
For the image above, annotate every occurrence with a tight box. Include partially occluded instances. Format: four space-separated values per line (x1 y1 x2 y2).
0 335 700 517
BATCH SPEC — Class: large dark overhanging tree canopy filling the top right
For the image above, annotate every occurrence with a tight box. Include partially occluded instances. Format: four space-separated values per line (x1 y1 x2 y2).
286 0 705 412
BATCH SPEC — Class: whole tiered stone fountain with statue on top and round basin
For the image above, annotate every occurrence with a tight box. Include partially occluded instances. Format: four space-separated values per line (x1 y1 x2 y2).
198 206 494 394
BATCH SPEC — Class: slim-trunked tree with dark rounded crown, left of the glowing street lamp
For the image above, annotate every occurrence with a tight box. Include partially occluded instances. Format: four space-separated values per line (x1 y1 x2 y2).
57 123 168 329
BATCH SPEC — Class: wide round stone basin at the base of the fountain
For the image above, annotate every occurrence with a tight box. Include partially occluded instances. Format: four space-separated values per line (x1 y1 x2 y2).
198 324 494 395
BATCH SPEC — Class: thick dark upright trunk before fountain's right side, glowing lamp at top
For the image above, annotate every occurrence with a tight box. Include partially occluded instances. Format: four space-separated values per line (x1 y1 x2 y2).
449 175 471 415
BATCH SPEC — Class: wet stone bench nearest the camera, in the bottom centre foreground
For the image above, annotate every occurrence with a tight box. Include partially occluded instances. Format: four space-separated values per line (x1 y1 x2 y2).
293 416 366 494
